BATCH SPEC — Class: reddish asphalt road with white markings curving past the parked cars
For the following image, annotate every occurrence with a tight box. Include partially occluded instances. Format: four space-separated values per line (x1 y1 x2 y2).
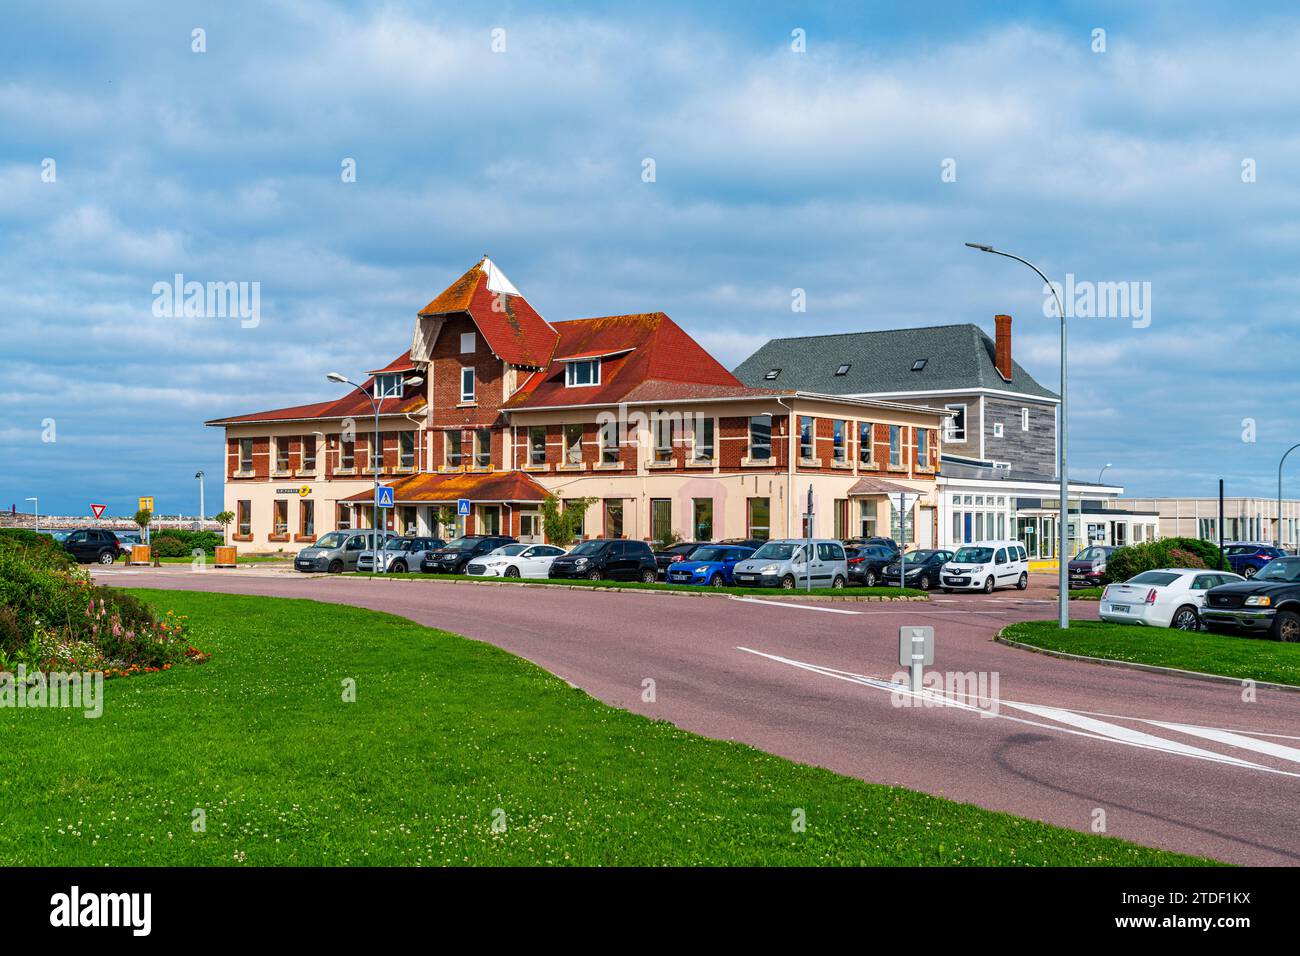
95 566 1300 865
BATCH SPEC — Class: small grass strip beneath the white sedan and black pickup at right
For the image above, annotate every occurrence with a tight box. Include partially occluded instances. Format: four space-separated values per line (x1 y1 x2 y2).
1002 620 1300 684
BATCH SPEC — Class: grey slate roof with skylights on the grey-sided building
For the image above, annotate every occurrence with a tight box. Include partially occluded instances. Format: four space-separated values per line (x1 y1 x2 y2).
735 323 1057 398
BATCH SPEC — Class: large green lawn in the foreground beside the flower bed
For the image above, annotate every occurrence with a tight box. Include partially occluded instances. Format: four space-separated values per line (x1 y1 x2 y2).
0 591 1208 866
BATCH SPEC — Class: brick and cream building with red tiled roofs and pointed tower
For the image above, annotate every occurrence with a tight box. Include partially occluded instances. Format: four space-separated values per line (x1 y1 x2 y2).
207 258 950 550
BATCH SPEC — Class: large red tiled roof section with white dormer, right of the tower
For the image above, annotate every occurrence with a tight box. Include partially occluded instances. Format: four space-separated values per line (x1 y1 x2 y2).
506 312 762 408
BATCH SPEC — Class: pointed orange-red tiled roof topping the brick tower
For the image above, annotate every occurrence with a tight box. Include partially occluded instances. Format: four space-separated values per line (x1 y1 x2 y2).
420 256 556 368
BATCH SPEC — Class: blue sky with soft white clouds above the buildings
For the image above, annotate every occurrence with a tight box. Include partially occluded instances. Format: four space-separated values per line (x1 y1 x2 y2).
0 0 1300 514
